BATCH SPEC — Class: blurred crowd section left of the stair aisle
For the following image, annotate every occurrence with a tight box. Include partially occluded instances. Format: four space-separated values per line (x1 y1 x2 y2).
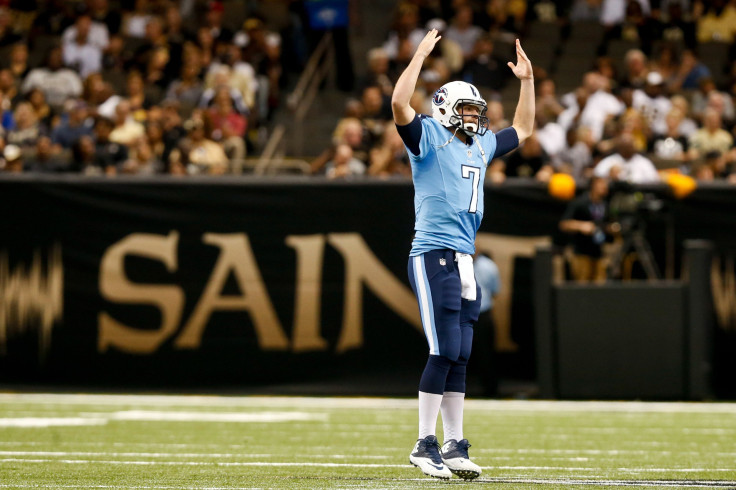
0 0 305 175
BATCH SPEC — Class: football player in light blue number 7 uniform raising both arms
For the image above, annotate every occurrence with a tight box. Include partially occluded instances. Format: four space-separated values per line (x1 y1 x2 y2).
391 29 534 480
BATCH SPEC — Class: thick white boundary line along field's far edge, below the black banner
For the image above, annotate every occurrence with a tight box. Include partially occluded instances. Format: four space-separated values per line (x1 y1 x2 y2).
0 393 736 414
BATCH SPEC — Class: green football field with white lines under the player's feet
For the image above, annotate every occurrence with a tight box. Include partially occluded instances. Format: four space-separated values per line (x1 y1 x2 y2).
0 393 736 489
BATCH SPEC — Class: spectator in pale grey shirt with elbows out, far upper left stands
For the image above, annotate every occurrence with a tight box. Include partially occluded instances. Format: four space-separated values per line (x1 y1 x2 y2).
21 46 82 110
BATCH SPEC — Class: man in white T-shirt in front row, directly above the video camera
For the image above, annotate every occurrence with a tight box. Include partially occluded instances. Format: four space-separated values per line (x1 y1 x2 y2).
593 133 659 184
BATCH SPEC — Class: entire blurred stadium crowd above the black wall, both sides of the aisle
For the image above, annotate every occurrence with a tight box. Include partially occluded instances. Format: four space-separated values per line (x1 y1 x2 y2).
0 0 736 183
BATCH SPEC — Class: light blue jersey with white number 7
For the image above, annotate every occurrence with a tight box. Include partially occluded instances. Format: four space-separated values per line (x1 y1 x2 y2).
408 116 496 256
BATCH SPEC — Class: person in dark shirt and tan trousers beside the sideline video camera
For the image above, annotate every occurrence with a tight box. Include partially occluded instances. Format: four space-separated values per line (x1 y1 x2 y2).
560 177 617 282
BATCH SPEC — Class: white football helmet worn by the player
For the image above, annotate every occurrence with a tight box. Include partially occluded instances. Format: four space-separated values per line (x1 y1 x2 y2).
432 81 488 135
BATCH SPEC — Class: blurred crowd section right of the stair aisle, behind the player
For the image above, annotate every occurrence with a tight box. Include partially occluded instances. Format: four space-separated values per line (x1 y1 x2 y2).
311 0 736 183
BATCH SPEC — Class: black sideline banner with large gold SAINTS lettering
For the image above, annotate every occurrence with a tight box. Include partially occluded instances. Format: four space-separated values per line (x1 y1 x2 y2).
0 176 736 396
